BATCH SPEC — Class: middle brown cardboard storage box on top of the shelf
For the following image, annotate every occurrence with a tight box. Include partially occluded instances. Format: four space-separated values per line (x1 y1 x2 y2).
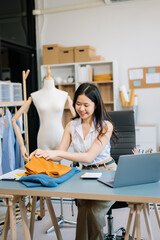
60 47 74 63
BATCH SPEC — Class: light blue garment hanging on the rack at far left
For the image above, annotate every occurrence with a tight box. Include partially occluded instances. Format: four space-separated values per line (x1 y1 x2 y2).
1 109 24 174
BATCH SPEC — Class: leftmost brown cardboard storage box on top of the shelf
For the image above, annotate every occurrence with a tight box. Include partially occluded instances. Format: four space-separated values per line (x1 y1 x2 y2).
43 44 63 65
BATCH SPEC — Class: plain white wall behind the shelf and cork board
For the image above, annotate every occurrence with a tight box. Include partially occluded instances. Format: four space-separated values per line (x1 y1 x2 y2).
37 0 160 148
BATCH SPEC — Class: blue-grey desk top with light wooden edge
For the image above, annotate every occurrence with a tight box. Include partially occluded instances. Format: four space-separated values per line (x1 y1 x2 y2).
0 170 160 203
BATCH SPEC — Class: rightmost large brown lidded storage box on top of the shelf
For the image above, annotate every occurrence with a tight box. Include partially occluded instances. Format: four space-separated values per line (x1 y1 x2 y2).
74 46 96 62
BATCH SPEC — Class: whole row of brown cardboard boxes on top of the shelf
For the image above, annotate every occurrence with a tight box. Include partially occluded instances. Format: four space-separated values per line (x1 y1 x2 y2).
43 44 105 65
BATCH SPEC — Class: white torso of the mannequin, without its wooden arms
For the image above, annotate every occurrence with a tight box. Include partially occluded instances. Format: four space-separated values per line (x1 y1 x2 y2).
31 79 68 149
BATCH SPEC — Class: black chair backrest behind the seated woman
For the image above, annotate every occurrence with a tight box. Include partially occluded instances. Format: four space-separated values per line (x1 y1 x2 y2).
108 110 136 163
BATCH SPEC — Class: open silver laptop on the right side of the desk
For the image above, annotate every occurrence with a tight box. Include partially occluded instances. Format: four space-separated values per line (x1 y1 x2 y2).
98 153 160 188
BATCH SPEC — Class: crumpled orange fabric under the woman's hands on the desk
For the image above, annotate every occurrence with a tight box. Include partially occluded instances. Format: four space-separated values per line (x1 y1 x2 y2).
21 156 72 177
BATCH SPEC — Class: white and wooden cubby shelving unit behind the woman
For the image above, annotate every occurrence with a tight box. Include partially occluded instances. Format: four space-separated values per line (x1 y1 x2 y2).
41 61 119 126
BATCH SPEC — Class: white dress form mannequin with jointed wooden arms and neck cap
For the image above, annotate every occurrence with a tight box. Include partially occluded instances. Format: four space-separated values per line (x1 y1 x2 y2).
12 67 75 161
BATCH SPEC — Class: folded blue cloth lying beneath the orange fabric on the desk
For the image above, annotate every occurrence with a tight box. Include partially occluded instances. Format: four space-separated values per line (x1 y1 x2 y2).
19 167 80 187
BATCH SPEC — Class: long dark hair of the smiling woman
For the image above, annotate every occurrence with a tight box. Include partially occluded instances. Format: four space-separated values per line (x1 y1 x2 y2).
73 83 117 142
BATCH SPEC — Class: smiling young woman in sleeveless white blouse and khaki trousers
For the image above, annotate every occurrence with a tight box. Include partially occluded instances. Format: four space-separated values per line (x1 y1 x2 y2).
30 83 116 240
